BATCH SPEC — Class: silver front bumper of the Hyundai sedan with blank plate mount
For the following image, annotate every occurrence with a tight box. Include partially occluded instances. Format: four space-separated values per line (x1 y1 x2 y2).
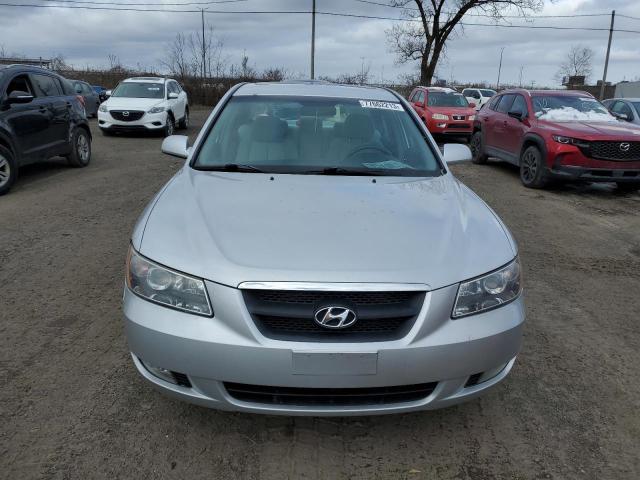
124 282 524 415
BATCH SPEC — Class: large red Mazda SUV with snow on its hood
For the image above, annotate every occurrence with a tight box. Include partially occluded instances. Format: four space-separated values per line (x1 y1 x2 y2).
471 90 640 190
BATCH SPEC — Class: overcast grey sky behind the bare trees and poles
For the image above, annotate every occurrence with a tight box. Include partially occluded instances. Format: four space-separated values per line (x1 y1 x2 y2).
0 0 640 86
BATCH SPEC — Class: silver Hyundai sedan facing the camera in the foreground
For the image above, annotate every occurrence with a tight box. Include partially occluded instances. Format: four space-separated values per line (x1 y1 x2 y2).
124 82 525 415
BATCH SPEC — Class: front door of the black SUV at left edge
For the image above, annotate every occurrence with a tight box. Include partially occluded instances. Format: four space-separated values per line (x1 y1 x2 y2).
1 73 51 164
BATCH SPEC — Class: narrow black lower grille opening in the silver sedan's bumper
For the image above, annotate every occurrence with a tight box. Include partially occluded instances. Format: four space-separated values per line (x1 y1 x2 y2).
224 382 437 407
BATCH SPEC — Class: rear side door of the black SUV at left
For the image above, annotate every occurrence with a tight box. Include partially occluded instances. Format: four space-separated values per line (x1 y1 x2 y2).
30 73 72 155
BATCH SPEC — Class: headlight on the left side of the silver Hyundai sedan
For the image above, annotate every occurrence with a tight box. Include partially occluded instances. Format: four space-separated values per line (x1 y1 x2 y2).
126 247 213 316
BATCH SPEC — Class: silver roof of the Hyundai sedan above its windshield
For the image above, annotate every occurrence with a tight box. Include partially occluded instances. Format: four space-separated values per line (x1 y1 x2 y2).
234 81 400 102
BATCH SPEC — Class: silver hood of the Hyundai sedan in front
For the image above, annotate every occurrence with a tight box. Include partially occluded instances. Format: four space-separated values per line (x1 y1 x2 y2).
138 167 515 289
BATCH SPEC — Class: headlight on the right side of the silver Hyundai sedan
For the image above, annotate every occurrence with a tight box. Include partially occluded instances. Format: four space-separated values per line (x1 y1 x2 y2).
451 258 522 318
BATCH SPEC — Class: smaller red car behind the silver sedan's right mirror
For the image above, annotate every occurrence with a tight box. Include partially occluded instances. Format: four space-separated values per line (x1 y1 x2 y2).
409 87 476 138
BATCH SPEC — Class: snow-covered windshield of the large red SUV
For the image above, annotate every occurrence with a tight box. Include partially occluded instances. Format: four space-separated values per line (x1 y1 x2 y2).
531 95 617 122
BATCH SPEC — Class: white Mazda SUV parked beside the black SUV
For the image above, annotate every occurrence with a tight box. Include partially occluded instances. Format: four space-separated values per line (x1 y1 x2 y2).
98 77 189 136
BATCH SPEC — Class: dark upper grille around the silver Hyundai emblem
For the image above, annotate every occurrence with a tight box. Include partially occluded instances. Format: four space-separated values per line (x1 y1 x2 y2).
243 290 425 342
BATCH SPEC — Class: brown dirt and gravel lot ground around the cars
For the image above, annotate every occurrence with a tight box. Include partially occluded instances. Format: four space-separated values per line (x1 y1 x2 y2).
0 110 640 479
